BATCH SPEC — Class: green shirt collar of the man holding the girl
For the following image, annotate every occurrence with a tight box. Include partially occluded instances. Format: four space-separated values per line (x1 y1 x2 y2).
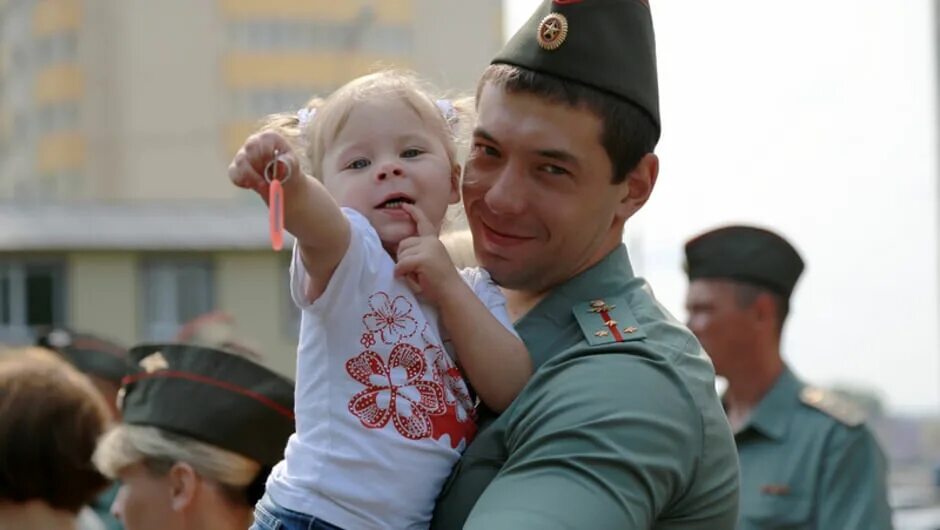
516 244 634 368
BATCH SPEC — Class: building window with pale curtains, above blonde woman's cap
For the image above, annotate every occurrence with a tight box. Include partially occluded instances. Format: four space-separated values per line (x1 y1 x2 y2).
141 259 215 341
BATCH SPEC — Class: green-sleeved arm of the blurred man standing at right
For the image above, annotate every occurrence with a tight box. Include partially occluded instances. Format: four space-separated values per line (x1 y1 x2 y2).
816 427 891 530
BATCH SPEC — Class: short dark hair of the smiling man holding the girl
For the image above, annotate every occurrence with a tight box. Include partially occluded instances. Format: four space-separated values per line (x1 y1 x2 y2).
477 64 659 184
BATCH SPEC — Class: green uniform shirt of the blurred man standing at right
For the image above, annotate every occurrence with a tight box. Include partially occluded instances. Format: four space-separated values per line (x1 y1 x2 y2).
735 369 891 530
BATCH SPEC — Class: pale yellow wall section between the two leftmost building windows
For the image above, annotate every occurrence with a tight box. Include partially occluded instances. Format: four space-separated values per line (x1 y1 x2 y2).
66 252 138 344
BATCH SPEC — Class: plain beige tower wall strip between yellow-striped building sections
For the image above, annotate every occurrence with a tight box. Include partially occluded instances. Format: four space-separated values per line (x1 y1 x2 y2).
98 0 235 199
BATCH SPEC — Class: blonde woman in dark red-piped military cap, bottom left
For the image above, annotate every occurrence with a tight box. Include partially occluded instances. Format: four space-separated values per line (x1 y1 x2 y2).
94 344 294 530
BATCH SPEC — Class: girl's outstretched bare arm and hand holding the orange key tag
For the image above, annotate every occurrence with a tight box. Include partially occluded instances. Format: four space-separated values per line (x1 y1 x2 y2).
228 131 350 302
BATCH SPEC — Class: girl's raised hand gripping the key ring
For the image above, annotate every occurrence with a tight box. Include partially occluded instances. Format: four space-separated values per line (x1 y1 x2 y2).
228 131 300 200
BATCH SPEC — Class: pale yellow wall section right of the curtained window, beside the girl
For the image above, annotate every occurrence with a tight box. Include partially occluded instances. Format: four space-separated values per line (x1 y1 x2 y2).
215 251 297 376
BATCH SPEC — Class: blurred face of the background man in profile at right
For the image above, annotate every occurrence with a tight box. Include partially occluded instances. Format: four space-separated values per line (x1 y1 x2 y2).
685 279 754 377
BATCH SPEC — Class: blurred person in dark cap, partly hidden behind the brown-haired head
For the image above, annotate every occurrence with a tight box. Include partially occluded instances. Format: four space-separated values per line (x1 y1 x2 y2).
36 328 130 530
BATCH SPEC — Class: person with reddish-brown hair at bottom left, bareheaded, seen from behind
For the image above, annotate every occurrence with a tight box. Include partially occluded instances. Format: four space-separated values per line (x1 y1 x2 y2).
0 348 109 530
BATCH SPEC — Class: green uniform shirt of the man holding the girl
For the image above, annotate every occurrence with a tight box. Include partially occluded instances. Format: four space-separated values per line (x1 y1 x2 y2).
432 246 738 530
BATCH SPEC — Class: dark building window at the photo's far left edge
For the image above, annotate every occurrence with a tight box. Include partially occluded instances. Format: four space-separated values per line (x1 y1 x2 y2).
0 260 65 344
